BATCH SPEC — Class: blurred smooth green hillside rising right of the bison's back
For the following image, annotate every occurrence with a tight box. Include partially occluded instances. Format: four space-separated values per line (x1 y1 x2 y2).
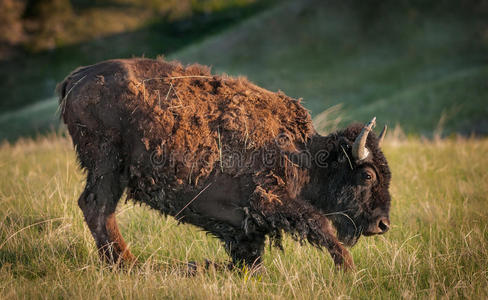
174 1 488 136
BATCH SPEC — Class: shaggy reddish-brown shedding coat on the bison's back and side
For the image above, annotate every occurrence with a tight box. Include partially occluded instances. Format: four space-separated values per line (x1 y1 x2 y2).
58 59 315 200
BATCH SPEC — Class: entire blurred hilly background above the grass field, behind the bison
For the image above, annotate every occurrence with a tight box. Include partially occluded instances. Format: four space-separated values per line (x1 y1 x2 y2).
0 0 488 141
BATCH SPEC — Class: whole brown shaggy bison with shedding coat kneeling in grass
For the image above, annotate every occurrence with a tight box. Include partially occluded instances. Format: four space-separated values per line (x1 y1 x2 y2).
57 59 391 269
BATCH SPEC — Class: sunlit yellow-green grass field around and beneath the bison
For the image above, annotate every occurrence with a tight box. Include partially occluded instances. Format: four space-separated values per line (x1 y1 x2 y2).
0 136 488 299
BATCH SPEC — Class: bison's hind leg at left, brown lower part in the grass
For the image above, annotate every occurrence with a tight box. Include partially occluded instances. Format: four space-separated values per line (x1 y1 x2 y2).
78 172 135 263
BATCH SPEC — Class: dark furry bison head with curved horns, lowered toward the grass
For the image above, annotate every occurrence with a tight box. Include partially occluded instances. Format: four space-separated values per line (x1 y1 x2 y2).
314 119 391 246
